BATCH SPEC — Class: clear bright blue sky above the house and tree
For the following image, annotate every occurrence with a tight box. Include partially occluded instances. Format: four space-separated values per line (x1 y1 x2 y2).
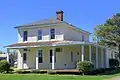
0 0 120 51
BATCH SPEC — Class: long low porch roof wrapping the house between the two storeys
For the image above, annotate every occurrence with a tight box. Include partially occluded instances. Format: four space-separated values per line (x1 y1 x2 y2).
5 41 103 48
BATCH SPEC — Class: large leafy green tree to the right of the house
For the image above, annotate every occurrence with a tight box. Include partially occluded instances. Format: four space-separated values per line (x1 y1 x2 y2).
93 13 120 59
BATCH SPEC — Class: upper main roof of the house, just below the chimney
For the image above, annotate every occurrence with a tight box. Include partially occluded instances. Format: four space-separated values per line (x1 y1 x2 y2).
15 19 91 34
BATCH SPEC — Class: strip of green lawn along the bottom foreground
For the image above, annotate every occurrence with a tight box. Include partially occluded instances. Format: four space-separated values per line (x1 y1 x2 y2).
0 74 120 80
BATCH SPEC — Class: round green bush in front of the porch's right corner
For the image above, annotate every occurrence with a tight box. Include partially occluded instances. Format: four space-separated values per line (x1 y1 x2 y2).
77 61 93 75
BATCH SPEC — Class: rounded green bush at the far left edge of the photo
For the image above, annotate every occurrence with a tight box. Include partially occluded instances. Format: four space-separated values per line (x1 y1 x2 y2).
0 60 10 73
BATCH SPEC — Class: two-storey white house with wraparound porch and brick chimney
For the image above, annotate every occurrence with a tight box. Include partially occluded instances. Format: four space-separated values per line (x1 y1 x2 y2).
7 11 115 69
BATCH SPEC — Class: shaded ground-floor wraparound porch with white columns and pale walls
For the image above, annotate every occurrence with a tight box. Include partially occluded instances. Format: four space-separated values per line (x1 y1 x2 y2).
8 41 109 69
